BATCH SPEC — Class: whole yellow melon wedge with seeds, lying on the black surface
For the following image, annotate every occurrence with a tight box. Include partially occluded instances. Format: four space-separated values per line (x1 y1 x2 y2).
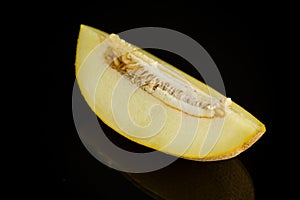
76 25 265 161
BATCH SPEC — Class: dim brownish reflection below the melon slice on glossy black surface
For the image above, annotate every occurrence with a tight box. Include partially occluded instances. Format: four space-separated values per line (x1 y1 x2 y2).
123 158 255 200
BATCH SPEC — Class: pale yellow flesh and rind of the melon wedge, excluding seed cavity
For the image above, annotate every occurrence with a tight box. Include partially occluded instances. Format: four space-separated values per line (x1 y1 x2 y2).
75 25 266 161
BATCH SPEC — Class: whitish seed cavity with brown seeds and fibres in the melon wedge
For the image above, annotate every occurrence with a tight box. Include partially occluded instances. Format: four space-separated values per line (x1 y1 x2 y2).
105 35 231 118
